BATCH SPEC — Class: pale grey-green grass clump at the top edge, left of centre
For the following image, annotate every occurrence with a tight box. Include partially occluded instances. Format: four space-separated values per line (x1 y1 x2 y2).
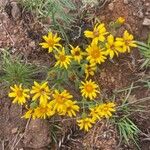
20 0 76 43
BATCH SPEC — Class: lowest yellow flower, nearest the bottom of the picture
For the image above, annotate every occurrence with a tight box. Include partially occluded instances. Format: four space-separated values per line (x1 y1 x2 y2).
77 117 95 131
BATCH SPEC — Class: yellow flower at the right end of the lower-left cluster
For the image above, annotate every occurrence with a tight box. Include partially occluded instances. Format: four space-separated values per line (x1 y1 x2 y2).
61 100 79 117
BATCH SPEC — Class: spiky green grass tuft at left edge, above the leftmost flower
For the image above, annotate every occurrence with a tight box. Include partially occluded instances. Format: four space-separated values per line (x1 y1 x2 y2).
0 49 39 85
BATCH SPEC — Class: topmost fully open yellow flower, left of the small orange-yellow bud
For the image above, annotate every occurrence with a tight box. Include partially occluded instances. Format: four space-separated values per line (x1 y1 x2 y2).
84 23 108 42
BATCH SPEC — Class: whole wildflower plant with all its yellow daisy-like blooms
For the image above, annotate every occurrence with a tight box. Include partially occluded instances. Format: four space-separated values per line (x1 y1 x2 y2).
9 18 136 131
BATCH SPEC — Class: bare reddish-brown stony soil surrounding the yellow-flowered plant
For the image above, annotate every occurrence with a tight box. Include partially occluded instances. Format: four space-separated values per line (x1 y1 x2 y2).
0 0 150 150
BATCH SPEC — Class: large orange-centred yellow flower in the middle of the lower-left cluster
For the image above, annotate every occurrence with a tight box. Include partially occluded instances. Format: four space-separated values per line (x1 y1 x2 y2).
50 90 73 114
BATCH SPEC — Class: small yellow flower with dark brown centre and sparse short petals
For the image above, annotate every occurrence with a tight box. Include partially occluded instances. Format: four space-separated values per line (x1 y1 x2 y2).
70 45 84 63
